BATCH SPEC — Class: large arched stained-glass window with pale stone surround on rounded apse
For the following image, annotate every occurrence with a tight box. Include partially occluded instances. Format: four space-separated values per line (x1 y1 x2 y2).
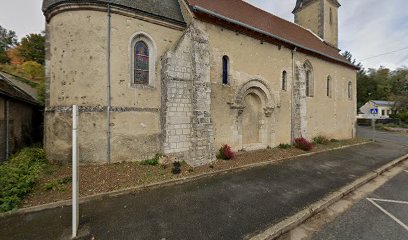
130 33 157 87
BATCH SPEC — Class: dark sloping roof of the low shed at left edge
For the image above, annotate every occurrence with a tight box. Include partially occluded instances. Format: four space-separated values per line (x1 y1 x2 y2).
0 72 38 105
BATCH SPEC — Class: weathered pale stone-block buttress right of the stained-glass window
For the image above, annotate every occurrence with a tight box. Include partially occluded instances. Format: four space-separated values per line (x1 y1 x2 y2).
162 22 215 166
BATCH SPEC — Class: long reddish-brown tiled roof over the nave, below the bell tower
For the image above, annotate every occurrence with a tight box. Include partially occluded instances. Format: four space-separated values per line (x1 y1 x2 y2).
186 0 358 69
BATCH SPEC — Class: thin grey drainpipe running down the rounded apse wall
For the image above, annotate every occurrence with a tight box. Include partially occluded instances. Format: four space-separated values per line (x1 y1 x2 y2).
106 4 111 164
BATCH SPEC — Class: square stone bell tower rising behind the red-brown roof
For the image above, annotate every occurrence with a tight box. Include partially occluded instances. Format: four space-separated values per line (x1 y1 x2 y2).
292 0 341 48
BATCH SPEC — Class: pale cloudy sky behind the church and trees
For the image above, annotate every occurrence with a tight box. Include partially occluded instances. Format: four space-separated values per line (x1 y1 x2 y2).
0 0 408 69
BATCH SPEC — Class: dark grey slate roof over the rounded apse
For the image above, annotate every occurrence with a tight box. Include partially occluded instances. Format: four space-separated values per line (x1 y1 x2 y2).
42 0 185 25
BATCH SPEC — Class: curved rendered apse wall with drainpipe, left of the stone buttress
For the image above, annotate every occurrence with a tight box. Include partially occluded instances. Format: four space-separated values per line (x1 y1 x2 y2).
44 7 183 163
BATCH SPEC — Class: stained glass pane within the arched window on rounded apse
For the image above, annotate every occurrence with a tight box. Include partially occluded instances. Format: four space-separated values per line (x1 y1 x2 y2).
134 41 149 84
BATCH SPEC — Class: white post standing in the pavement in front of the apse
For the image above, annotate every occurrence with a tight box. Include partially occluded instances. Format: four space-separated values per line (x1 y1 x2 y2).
72 105 79 238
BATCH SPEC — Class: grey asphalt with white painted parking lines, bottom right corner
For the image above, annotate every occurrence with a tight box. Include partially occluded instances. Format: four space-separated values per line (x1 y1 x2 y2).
312 170 408 240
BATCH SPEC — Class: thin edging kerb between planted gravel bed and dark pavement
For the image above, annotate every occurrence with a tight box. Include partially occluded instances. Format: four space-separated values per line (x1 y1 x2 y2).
0 141 373 218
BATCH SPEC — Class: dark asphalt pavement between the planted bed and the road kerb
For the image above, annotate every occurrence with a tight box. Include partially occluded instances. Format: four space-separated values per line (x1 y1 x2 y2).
0 126 408 240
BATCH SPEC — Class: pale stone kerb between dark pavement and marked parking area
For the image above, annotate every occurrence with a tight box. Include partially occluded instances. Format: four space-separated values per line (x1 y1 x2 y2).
246 154 408 240
